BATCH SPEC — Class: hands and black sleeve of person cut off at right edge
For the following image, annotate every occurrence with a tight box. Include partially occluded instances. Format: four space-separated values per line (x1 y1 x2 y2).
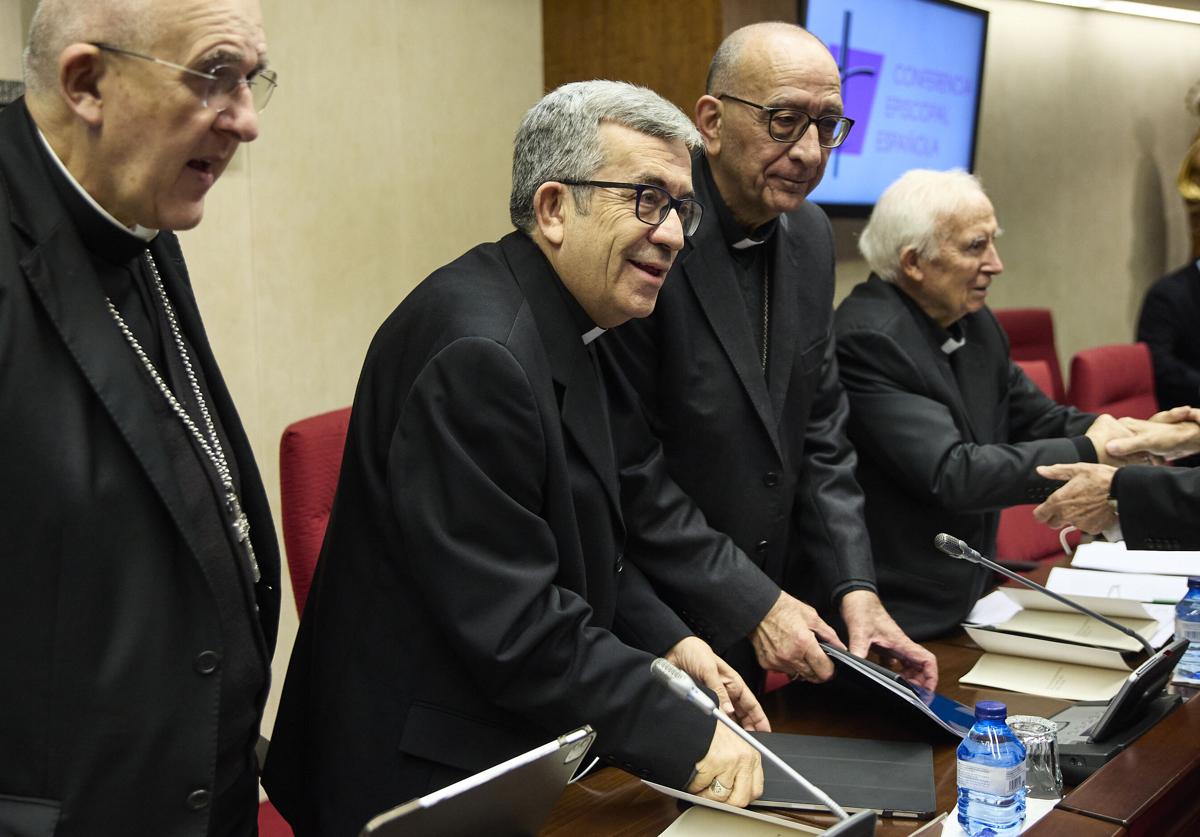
1034 407 1200 549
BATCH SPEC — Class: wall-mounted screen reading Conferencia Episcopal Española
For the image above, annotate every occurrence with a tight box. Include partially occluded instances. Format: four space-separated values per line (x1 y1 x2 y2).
800 0 988 216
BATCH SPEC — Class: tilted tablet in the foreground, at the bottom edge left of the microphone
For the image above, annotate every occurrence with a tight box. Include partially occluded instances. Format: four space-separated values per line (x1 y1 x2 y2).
359 727 595 837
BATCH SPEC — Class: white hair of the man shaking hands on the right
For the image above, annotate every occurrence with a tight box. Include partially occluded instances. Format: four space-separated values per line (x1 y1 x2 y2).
858 169 988 282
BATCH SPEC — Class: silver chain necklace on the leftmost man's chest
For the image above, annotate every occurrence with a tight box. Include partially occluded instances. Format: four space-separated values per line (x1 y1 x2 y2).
104 251 263 584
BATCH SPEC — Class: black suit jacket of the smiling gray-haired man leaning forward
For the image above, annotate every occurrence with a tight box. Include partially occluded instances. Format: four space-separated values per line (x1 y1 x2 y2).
264 233 768 836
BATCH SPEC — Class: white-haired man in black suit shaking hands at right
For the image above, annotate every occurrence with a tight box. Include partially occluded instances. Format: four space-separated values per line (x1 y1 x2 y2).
835 169 1128 639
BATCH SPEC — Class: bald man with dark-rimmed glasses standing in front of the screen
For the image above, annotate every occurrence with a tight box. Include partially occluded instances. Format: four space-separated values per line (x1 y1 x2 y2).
606 23 937 688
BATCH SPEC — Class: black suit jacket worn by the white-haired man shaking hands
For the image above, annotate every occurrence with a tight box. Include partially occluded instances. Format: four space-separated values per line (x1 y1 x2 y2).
835 276 1094 640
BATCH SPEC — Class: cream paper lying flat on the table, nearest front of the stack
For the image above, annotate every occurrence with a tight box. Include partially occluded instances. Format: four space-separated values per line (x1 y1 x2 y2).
959 654 1129 700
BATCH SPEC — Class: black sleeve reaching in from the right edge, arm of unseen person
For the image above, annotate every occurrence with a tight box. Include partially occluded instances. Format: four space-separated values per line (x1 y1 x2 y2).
1116 465 1200 549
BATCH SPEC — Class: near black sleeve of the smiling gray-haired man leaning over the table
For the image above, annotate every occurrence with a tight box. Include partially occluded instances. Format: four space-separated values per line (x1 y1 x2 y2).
388 338 713 787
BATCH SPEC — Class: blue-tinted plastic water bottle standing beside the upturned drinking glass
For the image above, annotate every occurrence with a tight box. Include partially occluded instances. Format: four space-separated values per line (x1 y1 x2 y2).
958 700 1025 837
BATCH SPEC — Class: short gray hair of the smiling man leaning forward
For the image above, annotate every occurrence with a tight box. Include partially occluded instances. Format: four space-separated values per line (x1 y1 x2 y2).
509 80 701 233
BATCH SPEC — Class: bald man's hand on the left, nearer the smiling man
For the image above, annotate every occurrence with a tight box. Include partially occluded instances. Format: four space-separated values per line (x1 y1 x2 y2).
750 592 846 682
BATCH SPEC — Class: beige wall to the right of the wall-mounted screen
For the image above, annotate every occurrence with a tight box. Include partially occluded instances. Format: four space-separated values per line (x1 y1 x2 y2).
835 0 1200 372
